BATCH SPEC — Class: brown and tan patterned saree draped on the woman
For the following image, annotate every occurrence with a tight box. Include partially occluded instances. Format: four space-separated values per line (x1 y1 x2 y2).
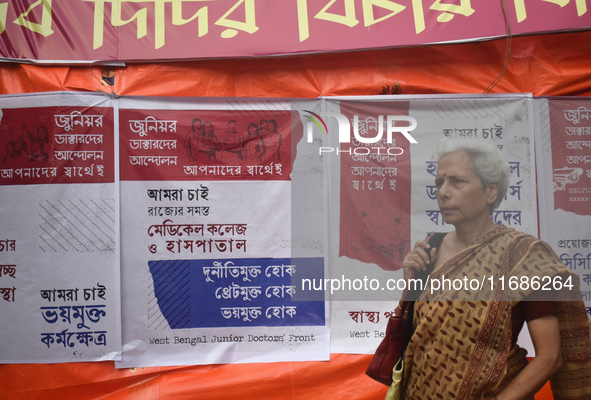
404 226 591 400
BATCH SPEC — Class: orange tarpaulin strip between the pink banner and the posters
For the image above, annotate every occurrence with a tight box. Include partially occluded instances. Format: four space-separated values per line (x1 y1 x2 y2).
0 31 591 98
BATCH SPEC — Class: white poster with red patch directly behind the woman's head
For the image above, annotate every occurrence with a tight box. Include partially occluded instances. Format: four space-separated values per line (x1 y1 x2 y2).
323 95 537 353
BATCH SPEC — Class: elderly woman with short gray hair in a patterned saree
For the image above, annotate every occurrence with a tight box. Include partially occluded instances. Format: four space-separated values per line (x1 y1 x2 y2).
403 139 591 400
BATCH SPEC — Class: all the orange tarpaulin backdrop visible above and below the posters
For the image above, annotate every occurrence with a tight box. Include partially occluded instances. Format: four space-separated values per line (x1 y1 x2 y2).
0 32 591 400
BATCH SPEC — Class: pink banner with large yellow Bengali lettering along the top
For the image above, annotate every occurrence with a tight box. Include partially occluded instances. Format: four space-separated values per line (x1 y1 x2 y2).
0 0 591 62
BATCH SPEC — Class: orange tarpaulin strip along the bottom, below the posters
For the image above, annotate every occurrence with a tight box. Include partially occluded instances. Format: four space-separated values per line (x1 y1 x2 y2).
0 354 552 400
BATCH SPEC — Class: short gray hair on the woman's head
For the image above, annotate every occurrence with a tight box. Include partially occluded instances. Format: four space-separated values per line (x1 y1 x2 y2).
434 138 511 213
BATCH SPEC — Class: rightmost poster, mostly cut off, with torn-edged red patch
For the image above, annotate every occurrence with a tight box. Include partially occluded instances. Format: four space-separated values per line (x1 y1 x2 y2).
536 97 591 316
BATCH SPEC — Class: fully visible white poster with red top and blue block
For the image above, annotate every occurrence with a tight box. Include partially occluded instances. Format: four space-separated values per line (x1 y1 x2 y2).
117 99 329 367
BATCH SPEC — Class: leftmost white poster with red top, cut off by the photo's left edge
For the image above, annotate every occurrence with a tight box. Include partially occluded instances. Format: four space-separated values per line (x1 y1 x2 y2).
0 93 121 363
